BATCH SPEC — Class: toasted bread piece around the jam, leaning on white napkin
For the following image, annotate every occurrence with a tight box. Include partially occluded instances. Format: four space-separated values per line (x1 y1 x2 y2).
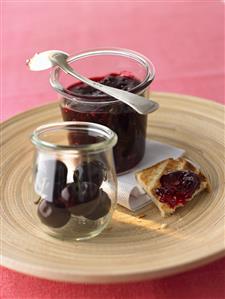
135 158 210 217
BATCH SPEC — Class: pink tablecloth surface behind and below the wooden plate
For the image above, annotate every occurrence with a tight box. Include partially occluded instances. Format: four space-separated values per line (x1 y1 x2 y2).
0 0 225 299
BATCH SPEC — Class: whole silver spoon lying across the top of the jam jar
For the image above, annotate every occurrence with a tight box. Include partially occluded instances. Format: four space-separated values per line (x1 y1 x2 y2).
27 50 159 114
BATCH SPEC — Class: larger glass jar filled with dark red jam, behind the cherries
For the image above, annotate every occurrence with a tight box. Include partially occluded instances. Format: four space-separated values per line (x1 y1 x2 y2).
50 49 155 174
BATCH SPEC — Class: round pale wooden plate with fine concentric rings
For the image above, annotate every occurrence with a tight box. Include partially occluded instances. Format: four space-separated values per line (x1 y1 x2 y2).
1 93 225 283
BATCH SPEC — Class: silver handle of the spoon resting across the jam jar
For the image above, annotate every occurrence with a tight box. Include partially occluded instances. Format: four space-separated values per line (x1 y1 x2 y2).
52 55 159 114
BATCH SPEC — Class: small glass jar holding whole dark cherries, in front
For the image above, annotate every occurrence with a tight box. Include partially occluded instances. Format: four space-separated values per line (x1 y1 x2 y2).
31 122 117 240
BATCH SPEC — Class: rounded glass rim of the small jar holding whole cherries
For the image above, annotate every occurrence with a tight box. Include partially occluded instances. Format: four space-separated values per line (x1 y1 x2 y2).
31 121 118 154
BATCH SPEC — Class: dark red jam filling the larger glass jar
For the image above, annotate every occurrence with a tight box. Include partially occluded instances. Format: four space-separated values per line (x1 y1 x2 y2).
61 72 147 173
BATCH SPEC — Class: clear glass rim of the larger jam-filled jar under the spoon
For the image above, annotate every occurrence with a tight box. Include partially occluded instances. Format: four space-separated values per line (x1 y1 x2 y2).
50 48 155 105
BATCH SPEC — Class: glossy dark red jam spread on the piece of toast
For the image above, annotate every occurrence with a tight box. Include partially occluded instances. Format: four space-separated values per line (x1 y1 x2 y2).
155 171 201 208
